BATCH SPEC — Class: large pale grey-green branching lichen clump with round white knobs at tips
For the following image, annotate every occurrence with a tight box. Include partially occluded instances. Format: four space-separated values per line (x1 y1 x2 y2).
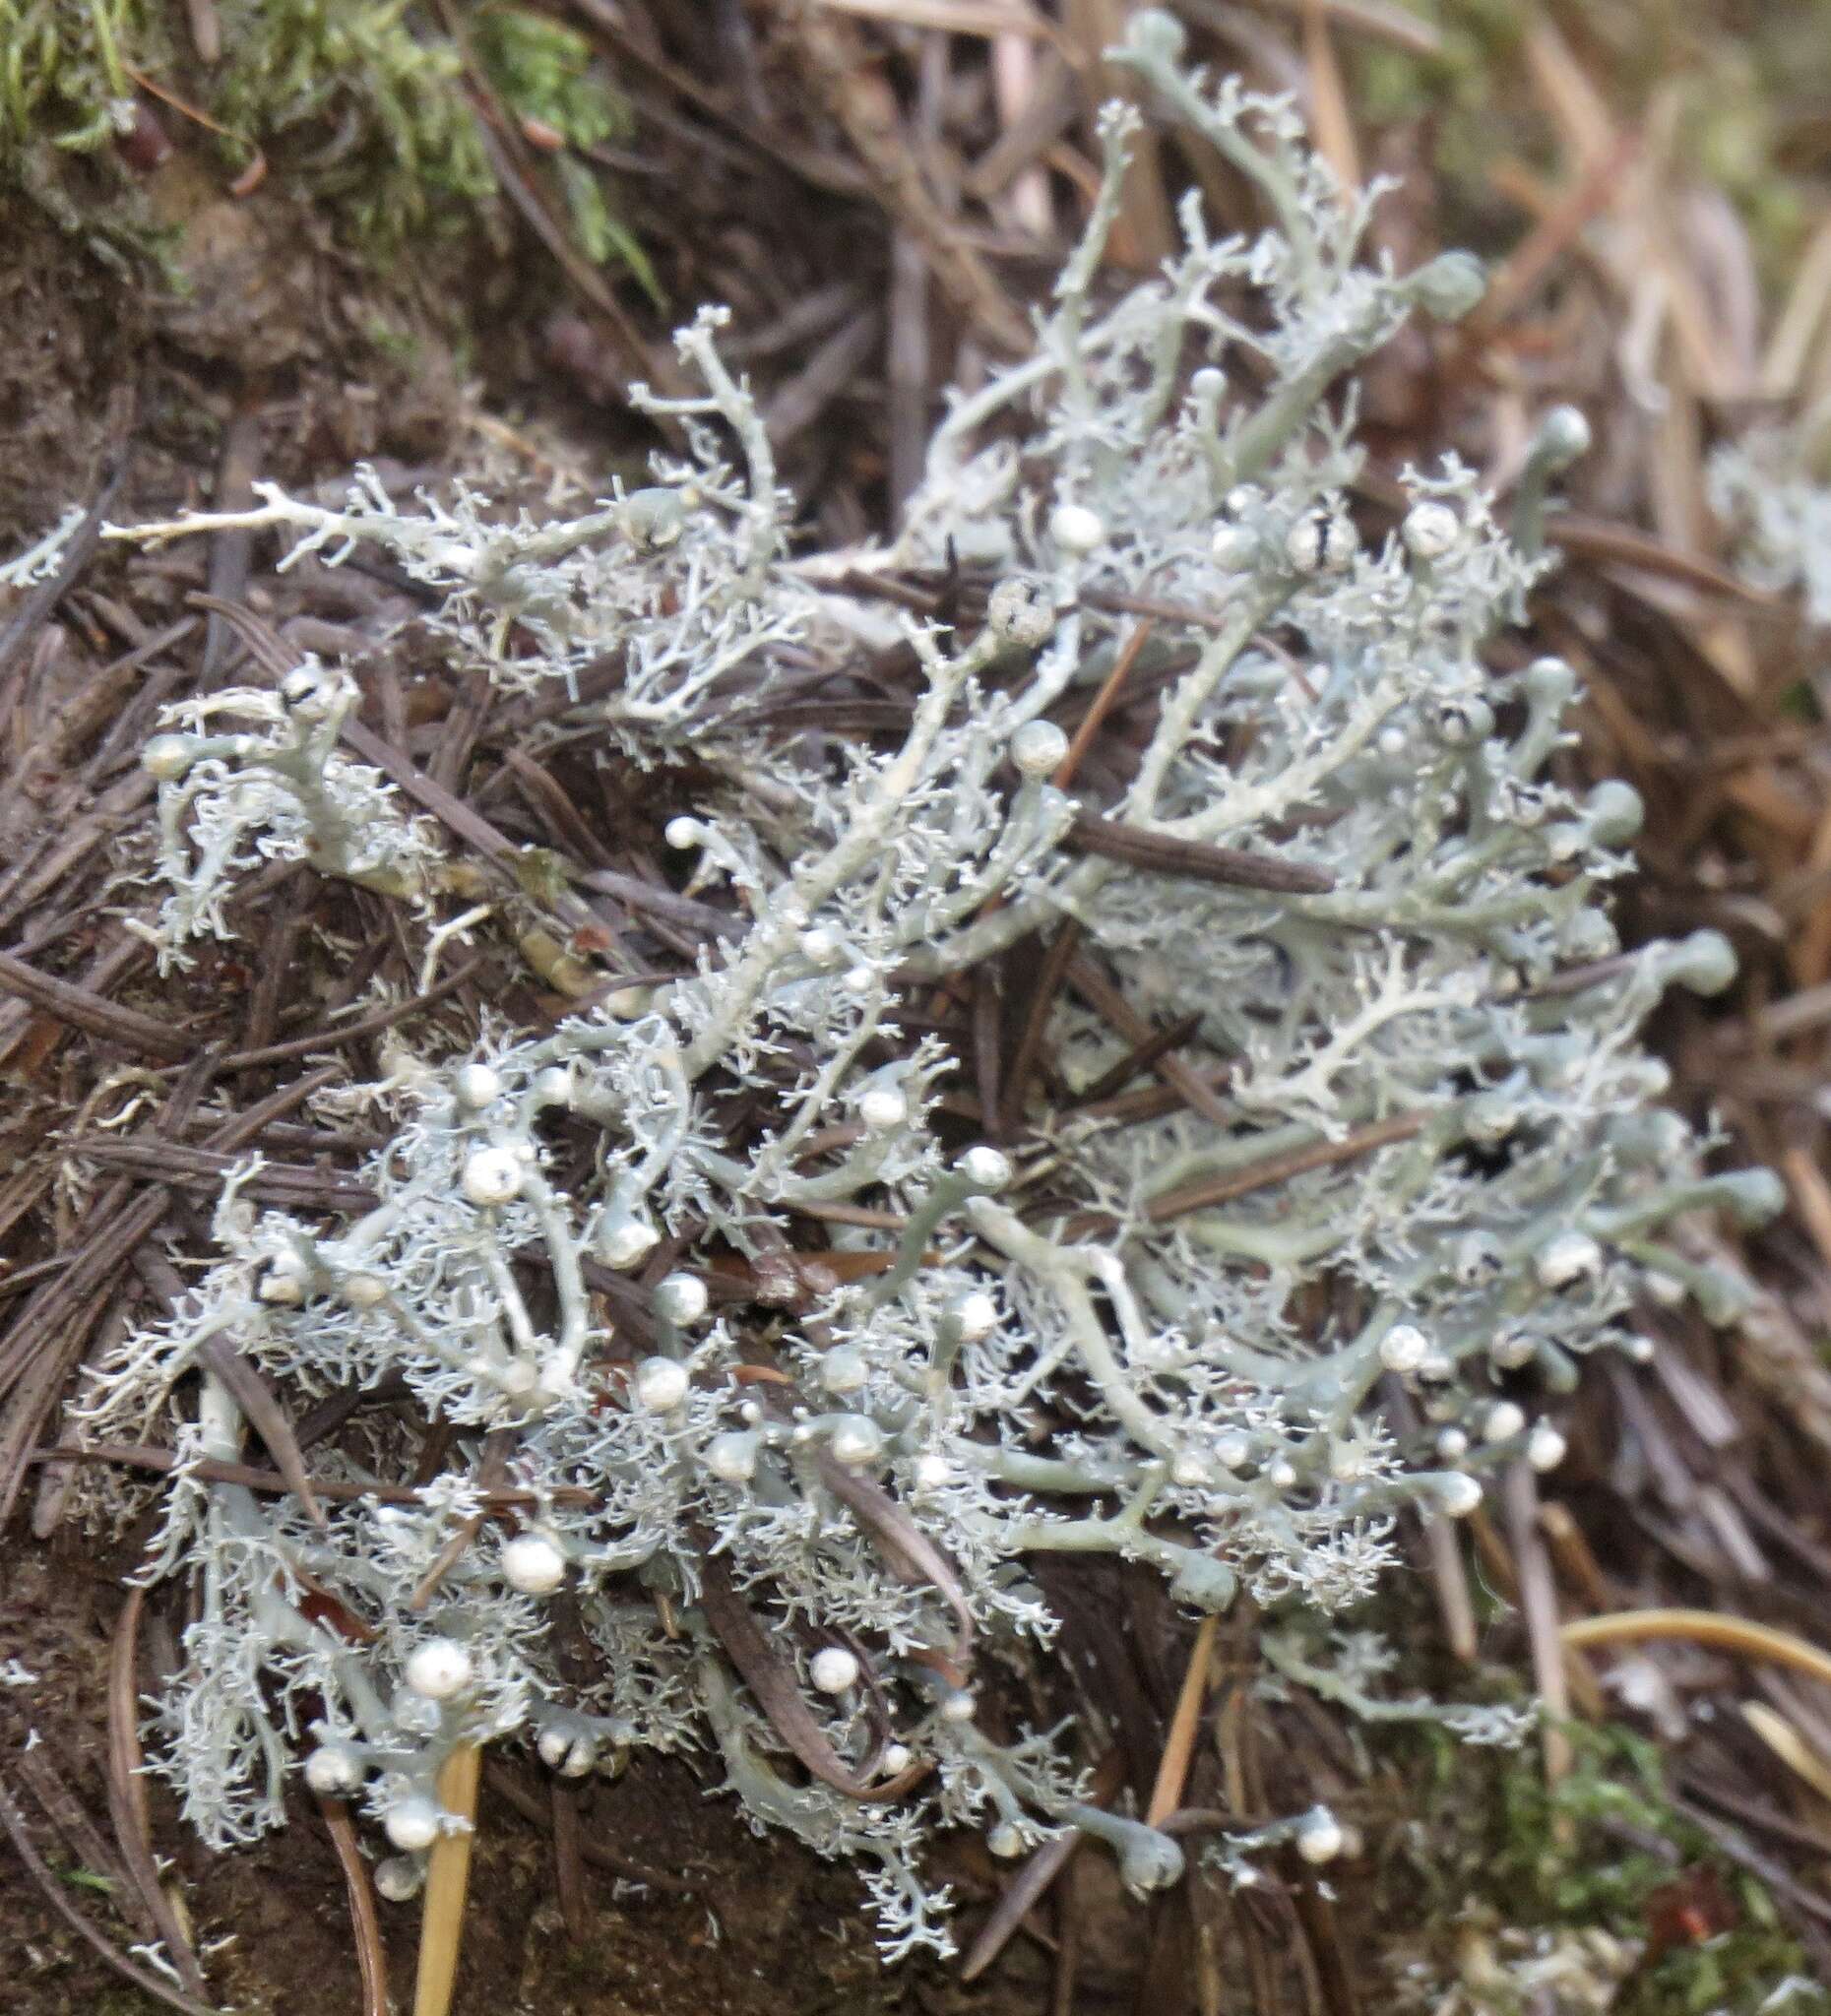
81 12 1775 1954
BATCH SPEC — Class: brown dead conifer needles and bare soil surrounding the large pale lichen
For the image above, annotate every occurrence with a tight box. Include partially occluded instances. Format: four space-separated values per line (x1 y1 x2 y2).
0 0 1831 2016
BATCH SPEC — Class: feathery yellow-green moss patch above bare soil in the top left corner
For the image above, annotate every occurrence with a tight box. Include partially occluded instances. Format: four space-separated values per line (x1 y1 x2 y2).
0 0 656 292
